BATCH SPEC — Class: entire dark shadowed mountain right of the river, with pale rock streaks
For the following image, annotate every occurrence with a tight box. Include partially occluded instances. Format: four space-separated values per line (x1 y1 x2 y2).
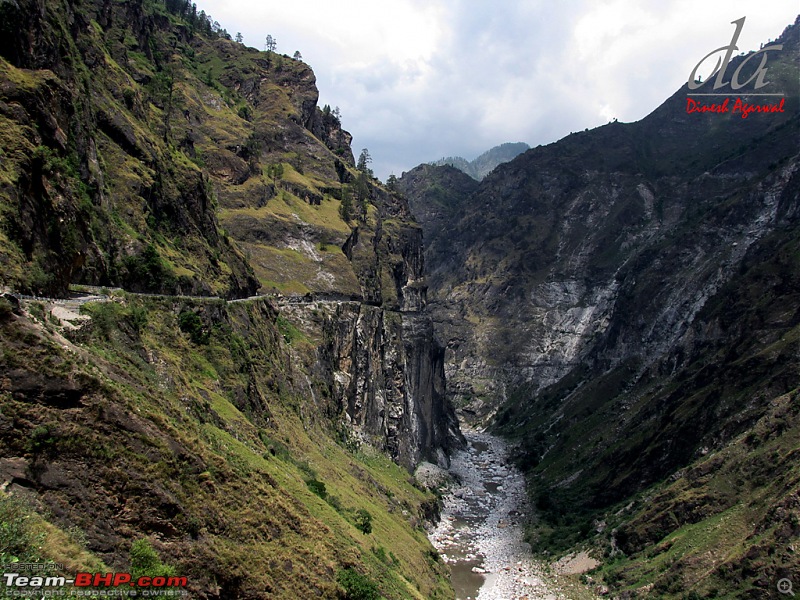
399 16 800 598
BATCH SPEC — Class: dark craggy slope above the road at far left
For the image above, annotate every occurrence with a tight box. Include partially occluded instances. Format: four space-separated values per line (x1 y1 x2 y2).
0 2 256 296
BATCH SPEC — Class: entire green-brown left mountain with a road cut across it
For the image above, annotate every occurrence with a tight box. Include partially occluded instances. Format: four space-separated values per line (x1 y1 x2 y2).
0 0 463 599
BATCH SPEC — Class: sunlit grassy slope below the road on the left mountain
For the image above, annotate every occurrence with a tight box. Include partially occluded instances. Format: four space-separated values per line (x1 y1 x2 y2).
0 298 449 598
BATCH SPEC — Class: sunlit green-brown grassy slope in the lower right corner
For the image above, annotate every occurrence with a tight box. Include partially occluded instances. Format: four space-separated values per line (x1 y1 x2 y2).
598 392 800 598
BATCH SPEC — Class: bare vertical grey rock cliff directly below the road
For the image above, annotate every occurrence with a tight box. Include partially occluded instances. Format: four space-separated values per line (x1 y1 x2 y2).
315 302 463 470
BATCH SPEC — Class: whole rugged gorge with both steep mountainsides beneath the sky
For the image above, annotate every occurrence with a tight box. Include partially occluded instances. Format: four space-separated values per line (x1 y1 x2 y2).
0 0 800 600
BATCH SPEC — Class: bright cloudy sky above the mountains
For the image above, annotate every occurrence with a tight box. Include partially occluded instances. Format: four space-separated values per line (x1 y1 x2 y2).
197 0 800 180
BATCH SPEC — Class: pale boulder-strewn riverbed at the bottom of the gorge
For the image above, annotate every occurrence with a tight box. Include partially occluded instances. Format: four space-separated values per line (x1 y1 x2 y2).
429 429 592 600
